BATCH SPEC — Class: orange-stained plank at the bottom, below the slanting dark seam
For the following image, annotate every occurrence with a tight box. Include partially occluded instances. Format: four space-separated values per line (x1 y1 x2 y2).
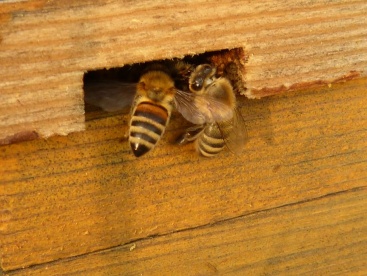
9 189 367 275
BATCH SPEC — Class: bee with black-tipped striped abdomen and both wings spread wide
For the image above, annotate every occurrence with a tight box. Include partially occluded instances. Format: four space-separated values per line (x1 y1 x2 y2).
84 62 232 157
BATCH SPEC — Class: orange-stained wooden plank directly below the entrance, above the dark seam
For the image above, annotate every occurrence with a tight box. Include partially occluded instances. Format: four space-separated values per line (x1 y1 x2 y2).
0 79 367 270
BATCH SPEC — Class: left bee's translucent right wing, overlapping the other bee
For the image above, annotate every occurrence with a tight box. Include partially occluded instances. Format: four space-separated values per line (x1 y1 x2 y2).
175 89 233 125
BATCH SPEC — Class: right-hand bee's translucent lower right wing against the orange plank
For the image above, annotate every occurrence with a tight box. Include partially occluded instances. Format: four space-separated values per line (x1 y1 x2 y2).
217 108 248 155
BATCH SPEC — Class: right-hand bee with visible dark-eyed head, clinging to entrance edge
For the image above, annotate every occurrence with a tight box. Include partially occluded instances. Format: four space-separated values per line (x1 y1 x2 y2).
178 64 247 157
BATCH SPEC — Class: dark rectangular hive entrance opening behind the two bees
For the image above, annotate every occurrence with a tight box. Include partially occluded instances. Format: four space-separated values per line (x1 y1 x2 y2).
83 48 246 116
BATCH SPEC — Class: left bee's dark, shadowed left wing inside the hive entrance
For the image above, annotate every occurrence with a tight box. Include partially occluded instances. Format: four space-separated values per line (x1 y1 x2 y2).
84 80 136 112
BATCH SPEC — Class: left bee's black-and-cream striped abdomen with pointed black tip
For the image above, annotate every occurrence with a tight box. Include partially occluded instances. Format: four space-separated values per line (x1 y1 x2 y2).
129 102 170 157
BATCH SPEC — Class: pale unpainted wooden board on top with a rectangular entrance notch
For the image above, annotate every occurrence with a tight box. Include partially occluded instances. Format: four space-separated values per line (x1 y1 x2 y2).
0 0 367 144
